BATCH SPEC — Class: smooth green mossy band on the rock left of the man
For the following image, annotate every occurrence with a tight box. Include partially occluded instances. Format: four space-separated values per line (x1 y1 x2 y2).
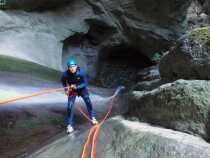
0 55 61 81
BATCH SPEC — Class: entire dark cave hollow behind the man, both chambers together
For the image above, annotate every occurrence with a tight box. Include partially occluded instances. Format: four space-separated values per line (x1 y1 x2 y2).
62 20 155 88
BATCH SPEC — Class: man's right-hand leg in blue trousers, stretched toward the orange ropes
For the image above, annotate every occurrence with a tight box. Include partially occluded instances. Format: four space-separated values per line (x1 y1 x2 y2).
80 89 95 124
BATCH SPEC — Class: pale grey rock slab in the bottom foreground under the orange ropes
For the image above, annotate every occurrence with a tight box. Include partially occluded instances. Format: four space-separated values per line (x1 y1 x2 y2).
29 117 210 158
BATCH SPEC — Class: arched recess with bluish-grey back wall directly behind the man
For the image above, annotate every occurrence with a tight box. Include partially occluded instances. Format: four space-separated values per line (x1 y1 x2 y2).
62 33 98 83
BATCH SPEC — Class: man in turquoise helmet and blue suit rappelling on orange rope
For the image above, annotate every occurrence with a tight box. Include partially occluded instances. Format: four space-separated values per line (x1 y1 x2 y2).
61 58 98 134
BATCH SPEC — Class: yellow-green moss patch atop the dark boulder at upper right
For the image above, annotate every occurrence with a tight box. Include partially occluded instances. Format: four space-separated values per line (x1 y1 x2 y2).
188 26 210 43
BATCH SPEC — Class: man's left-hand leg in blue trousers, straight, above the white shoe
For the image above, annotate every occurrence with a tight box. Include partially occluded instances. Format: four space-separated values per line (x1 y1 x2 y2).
67 96 76 126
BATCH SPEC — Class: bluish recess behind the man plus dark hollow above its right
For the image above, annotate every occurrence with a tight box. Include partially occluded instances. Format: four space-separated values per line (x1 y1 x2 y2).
62 19 116 83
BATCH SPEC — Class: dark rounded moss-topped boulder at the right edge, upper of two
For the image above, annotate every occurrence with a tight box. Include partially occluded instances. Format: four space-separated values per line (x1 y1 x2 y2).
159 27 210 80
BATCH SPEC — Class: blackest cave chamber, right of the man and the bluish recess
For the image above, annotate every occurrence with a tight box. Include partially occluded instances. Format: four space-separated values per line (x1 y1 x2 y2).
97 44 155 87
